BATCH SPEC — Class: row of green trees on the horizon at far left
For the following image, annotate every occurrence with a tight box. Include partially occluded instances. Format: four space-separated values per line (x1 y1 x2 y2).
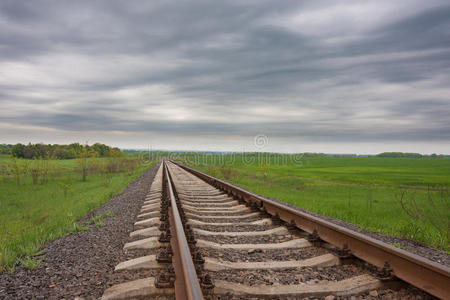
0 143 122 159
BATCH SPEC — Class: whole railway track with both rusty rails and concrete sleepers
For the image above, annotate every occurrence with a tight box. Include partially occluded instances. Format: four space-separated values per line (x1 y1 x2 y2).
102 161 450 300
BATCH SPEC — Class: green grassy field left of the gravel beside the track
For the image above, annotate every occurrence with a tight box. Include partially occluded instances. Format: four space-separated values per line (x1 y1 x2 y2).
0 156 151 272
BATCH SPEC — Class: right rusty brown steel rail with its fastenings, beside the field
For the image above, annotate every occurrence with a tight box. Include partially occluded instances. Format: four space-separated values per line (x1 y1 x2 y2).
174 162 450 299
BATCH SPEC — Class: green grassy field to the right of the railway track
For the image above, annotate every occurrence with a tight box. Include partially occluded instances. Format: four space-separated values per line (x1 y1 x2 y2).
180 154 450 252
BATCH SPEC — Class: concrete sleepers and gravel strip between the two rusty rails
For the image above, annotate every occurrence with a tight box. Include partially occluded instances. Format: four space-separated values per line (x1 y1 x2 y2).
168 163 430 299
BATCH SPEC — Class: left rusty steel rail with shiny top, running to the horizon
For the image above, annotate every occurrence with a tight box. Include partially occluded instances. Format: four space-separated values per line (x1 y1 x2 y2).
164 163 203 300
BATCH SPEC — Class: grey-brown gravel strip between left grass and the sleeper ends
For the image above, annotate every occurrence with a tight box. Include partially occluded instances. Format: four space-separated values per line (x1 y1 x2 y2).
0 164 159 299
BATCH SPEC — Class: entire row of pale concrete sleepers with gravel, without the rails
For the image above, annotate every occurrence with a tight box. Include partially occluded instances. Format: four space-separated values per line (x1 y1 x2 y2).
102 162 438 299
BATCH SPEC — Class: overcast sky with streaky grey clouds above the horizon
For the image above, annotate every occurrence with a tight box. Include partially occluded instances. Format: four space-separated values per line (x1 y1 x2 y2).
0 0 450 153
